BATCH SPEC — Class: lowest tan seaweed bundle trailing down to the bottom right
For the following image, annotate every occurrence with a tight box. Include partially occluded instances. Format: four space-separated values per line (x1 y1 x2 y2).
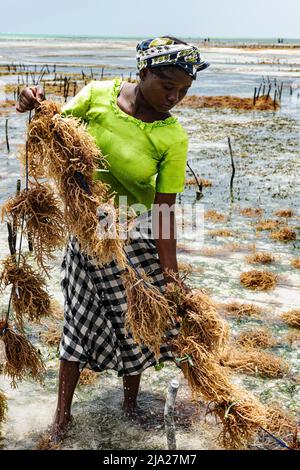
175 333 265 449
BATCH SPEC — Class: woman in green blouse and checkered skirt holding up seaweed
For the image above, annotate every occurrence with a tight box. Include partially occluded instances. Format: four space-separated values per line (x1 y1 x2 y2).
17 37 209 439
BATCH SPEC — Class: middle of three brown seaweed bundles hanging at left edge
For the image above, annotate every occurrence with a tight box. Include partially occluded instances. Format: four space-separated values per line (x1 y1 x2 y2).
0 255 51 330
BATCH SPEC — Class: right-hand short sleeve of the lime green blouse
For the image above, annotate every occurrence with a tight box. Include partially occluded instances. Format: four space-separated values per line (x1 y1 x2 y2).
156 139 188 193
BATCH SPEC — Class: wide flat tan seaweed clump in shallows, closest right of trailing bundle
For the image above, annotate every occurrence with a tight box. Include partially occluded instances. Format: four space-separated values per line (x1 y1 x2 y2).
220 347 289 378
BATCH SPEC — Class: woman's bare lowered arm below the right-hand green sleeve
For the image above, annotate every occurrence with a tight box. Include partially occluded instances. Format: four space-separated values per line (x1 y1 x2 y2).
152 192 178 281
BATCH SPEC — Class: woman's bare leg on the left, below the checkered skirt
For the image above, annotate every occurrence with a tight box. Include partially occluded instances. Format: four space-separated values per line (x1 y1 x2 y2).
51 359 80 440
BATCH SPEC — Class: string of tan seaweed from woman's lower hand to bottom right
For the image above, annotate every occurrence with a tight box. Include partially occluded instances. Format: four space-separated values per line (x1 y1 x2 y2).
162 277 265 449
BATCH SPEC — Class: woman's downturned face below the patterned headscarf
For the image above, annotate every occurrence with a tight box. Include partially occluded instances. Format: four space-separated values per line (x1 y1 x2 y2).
140 67 193 113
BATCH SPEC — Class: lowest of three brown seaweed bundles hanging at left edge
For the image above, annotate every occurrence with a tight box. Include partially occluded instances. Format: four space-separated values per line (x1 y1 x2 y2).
0 321 45 388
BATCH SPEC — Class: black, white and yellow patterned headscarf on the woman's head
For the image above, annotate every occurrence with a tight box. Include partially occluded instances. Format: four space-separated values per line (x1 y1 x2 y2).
136 37 210 79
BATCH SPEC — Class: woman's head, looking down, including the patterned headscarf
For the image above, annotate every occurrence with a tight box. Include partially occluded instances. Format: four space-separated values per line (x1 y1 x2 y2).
137 36 209 113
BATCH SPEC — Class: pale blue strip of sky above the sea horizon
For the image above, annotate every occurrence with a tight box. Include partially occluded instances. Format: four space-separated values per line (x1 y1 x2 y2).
0 0 300 38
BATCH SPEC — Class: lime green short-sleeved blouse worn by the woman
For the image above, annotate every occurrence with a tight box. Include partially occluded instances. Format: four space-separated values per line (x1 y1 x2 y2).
62 79 188 213
